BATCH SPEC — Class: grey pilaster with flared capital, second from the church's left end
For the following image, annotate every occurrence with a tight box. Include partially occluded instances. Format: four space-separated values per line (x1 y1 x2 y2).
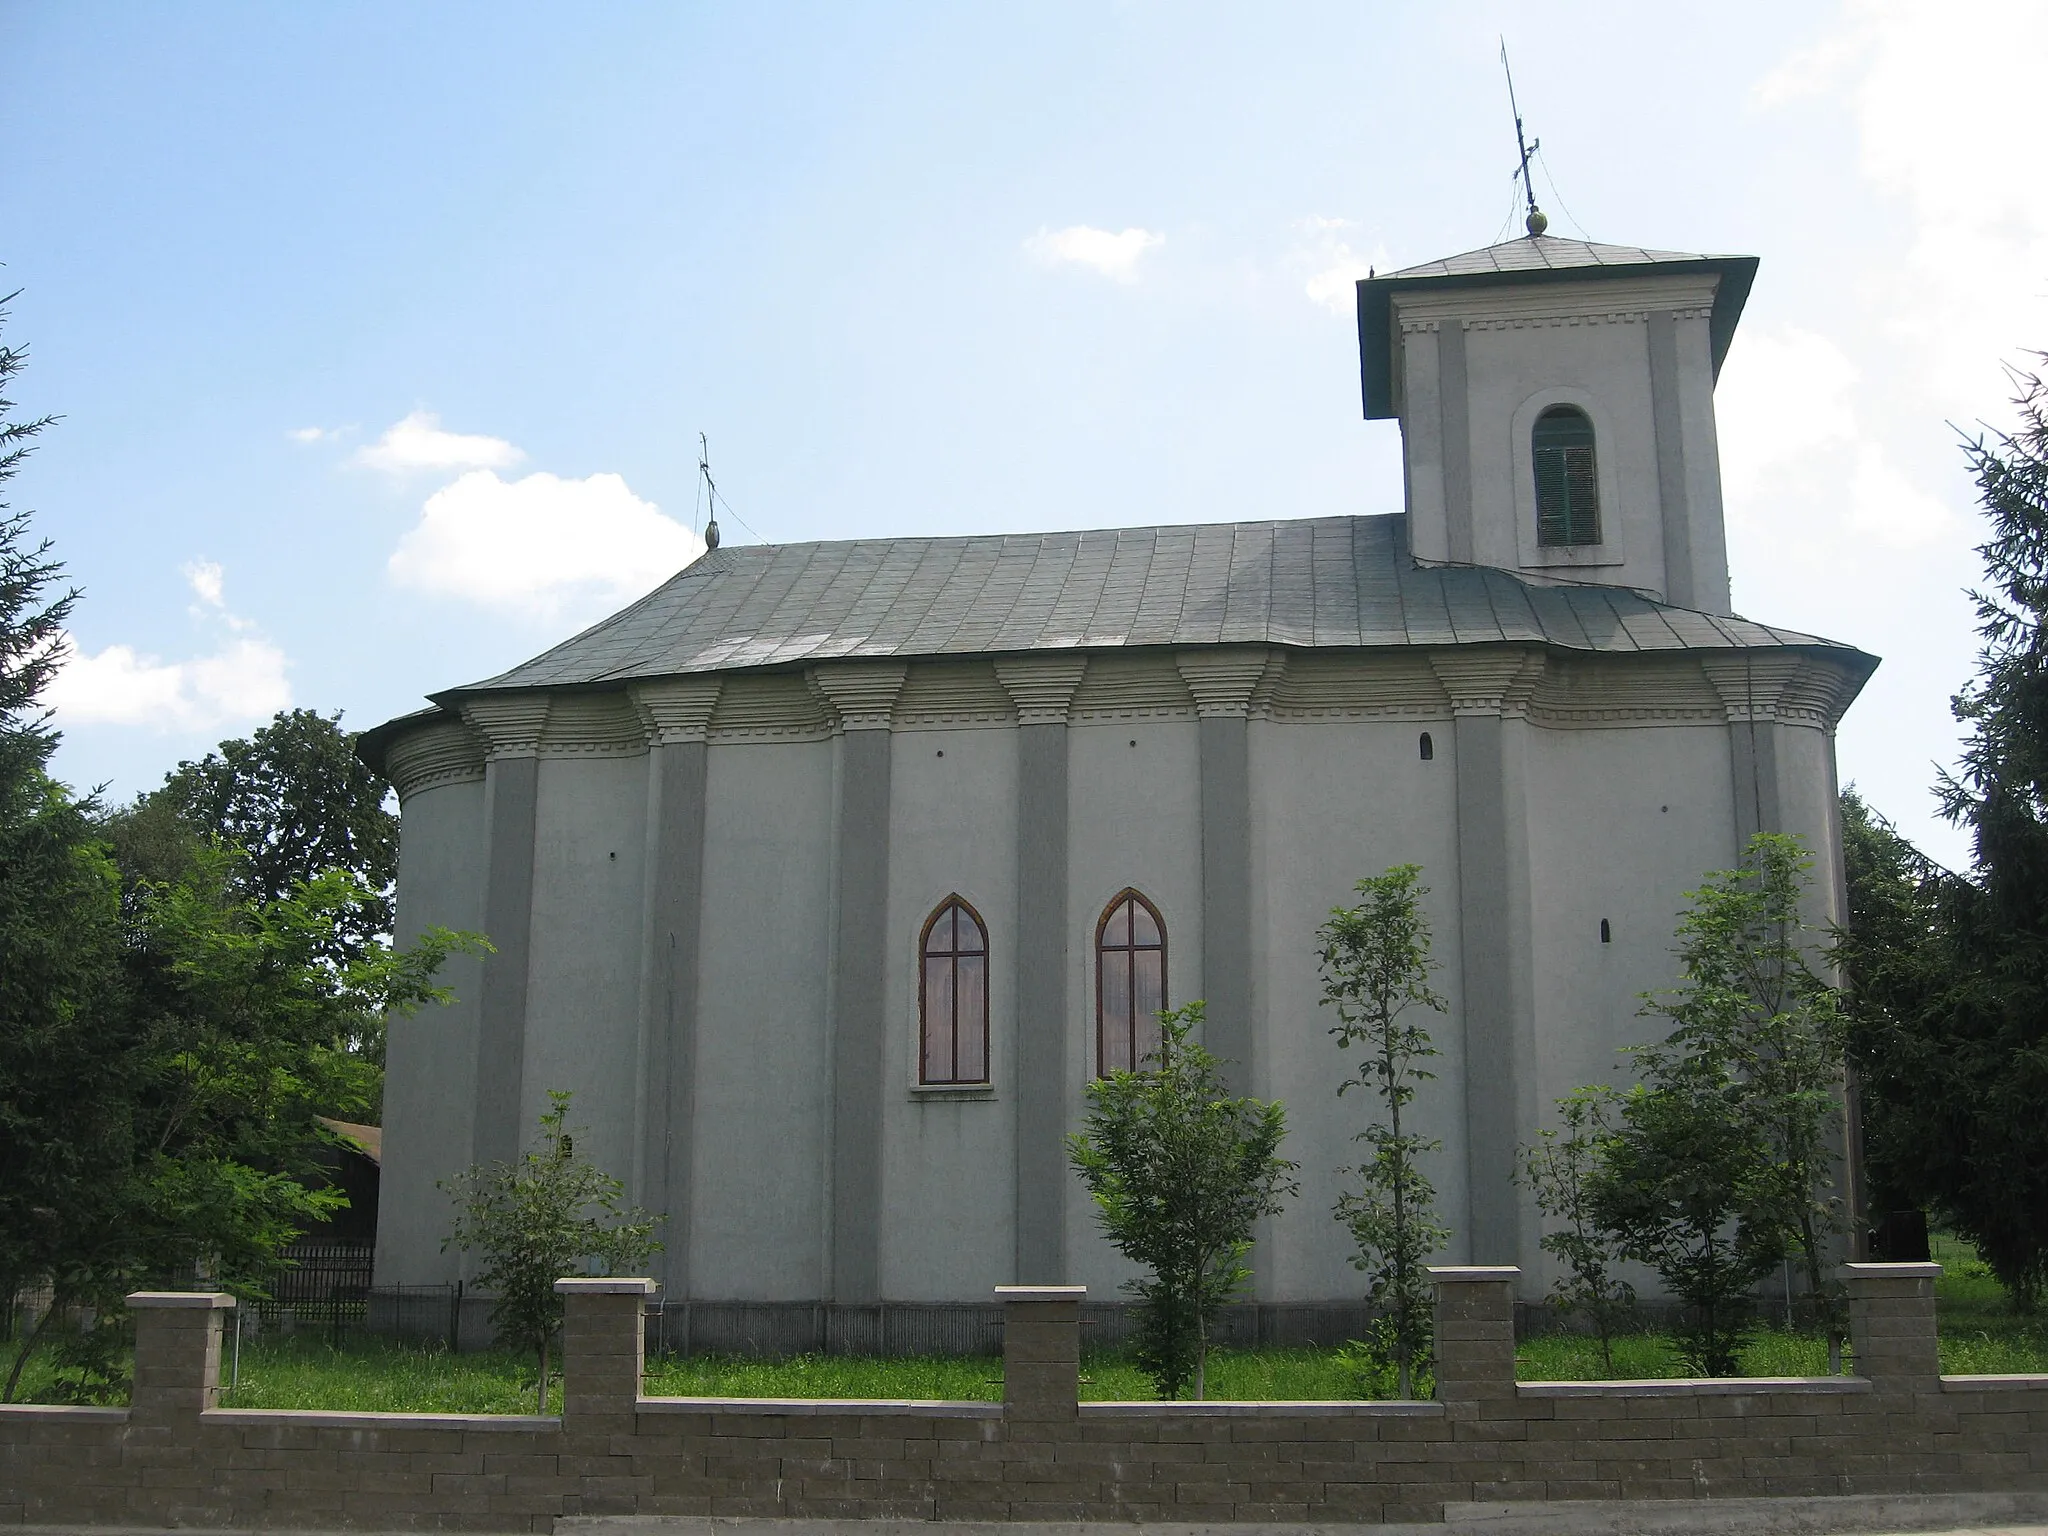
629 676 721 1296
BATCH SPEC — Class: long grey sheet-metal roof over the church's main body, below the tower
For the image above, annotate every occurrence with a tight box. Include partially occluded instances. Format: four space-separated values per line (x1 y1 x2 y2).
434 516 1874 705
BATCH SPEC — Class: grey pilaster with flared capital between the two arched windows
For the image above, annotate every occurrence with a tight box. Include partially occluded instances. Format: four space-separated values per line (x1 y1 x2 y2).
995 655 1087 1284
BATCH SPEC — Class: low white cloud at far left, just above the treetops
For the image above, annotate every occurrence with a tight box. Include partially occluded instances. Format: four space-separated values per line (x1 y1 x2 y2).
43 635 291 731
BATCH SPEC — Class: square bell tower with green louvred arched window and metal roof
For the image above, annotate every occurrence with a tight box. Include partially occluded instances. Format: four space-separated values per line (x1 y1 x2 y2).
1358 236 1757 614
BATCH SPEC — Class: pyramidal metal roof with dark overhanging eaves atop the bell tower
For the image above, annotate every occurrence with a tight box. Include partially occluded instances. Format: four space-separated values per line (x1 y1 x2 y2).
1358 236 1757 420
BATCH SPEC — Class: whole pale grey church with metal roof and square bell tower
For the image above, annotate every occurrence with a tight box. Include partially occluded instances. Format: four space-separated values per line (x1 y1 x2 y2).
362 228 1876 1305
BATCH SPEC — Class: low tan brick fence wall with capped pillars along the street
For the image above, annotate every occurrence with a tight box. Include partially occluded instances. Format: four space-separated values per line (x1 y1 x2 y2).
0 1264 2048 1530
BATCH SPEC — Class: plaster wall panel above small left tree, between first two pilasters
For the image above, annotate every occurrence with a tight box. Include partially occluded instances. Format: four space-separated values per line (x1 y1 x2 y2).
520 752 647 1178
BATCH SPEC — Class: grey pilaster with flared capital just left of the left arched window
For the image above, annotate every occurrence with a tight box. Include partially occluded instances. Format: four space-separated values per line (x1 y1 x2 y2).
807 662 905 1303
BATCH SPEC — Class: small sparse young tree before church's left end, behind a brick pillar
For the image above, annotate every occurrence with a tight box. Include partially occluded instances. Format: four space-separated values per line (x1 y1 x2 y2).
440 1090 662 1413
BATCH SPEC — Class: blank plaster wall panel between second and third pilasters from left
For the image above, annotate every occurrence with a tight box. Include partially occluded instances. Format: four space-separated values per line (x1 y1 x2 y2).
690 741 834 1300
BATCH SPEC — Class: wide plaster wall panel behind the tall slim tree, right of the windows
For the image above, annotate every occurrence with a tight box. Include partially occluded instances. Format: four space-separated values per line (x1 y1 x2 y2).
1251 717 1466 1300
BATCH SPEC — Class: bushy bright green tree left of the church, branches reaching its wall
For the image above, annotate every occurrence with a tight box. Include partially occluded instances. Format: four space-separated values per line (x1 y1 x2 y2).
0 842 479 1397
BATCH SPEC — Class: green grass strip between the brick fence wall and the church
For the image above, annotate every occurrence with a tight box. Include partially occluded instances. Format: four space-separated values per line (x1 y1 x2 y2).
0 1239 2048 1413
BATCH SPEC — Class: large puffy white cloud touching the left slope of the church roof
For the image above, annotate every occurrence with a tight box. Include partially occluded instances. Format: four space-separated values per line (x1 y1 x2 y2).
389 469 705 621
